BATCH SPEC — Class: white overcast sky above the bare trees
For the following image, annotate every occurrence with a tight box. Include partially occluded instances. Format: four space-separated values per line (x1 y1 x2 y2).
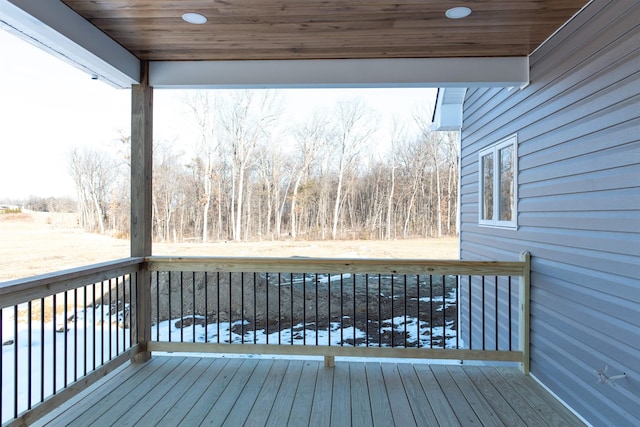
0 29 435 200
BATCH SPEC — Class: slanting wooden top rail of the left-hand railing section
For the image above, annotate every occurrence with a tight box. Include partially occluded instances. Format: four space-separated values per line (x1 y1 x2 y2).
0 257 144 308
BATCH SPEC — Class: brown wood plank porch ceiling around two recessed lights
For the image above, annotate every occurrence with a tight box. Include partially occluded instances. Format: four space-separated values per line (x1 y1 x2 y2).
63 0 588 61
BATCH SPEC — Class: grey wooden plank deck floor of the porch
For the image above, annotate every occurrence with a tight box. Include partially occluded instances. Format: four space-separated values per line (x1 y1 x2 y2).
37 356 583 427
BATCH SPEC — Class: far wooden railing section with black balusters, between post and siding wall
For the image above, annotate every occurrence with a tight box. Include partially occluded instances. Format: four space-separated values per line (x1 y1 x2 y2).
147 255 529 372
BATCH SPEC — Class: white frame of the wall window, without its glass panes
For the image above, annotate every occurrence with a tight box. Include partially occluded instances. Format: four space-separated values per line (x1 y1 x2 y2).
478 134 518 229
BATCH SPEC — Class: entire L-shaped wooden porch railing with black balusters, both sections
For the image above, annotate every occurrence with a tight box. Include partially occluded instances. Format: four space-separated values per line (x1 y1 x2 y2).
0 254 530 425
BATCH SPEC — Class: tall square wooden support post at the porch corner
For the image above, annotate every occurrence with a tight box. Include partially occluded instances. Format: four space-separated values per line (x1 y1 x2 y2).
131 62 153 362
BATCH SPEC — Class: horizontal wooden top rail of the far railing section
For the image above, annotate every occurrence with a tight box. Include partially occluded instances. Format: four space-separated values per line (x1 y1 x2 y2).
145 256 525 276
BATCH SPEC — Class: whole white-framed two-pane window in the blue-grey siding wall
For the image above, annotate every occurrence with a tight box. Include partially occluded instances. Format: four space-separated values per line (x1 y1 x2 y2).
479 135 518 228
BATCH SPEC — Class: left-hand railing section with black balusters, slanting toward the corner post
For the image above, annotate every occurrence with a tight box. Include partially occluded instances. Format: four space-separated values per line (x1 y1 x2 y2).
0 258 144 424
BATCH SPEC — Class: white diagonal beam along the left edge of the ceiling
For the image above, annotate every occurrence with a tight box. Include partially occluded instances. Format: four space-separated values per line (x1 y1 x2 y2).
0 0 140 88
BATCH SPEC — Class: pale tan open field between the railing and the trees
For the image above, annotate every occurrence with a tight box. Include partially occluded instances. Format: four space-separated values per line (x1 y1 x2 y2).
0 212 458 282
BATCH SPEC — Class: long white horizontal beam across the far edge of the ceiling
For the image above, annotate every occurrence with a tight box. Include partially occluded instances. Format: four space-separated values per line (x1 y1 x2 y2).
149 57 529 88
